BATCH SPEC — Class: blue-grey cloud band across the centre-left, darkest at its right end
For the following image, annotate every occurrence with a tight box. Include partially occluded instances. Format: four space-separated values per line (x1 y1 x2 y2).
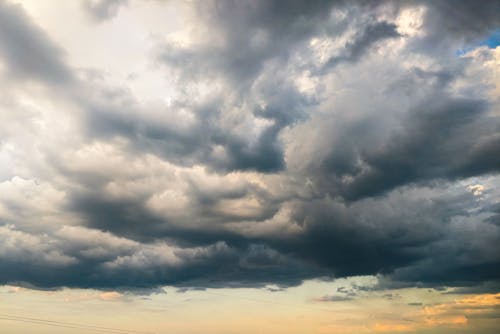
78 66 315 173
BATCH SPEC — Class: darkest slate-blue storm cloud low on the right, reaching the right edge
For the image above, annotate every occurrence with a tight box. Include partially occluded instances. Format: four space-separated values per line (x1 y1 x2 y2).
285 187 500 286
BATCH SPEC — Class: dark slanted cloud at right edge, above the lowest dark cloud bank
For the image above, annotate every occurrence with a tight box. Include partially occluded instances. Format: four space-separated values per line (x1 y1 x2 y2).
336 98 500 199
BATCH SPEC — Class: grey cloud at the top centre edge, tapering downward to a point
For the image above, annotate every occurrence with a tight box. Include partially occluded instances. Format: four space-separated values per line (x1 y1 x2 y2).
173 0 337 89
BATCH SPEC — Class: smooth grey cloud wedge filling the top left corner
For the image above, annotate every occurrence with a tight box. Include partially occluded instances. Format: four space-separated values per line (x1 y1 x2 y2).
0 2 73 85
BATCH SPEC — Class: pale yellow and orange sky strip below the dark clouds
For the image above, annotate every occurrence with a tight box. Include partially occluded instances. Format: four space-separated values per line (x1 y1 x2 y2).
0 277 500 334
